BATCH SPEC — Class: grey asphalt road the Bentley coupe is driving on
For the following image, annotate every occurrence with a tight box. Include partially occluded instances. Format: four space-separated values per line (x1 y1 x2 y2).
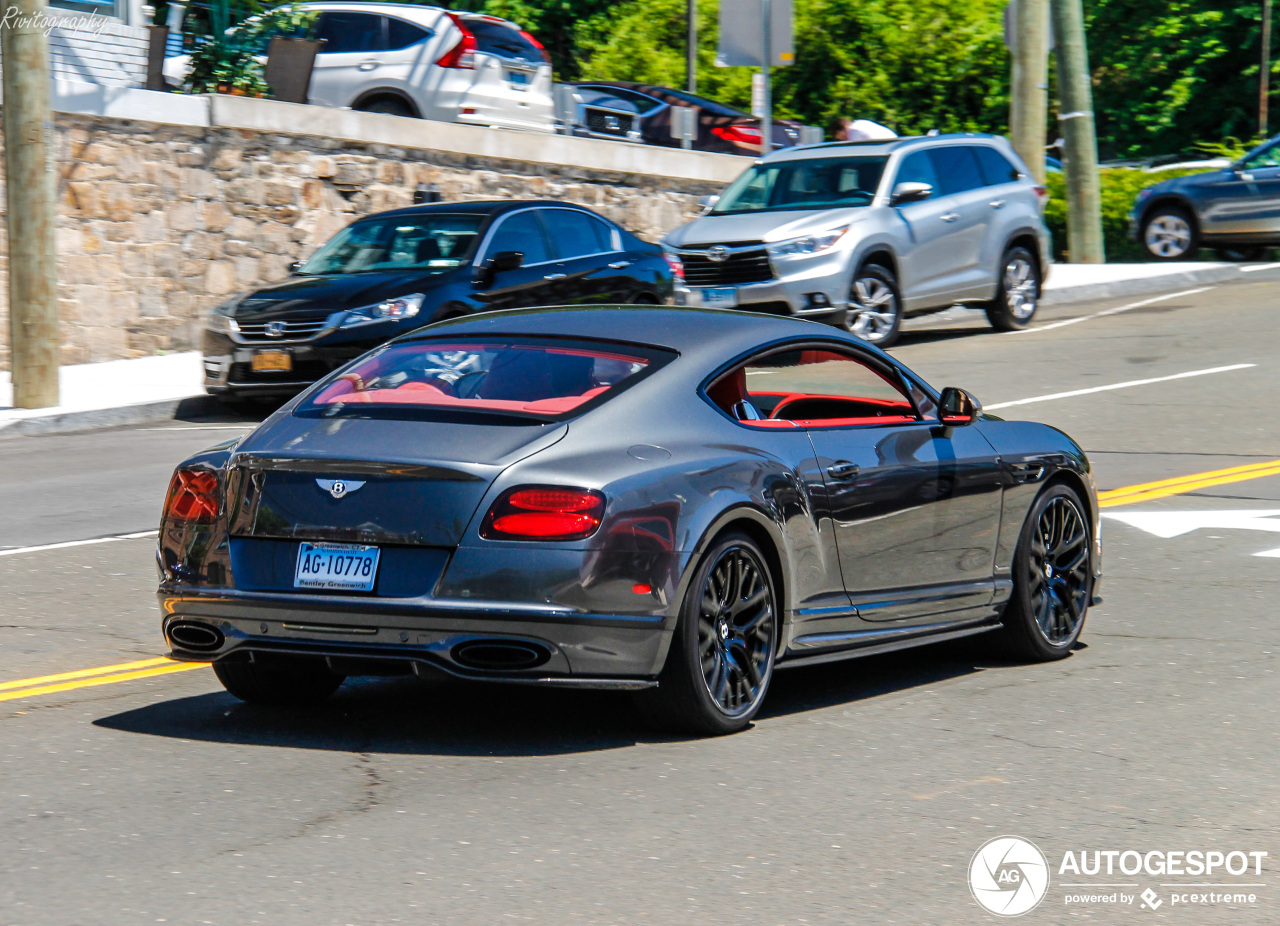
0 273 1280 926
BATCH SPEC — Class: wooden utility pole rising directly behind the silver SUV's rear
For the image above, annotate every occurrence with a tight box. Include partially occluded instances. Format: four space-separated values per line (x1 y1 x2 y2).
1009 0 1048 183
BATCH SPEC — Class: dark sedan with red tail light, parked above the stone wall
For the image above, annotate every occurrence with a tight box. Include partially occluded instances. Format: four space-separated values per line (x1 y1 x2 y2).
572 81 801 158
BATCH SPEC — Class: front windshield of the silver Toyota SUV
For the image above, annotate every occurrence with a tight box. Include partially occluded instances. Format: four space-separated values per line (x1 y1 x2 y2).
712 156 888 215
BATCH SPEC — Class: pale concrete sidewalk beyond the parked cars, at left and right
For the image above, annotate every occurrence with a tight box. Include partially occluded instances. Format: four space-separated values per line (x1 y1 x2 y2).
0 261 1280 439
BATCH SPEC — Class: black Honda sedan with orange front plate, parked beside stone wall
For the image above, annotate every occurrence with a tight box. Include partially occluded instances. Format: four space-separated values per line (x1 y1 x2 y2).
204 201 672 401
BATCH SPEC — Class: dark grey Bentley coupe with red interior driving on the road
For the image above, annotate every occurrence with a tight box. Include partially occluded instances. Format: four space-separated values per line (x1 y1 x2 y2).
159 306 1101 734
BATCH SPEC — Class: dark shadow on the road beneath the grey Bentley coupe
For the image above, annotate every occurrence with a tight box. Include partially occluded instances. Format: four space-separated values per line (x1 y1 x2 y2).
93 642 1024 756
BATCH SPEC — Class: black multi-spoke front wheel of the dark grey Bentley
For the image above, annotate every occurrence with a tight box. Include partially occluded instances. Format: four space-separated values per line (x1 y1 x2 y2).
1004 485 1093 662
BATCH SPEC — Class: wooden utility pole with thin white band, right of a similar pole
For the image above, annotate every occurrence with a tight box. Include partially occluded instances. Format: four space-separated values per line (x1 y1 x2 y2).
1052 0 1106 264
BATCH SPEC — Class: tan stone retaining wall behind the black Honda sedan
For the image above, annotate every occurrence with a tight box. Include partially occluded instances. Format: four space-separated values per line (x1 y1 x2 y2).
0 108 721 369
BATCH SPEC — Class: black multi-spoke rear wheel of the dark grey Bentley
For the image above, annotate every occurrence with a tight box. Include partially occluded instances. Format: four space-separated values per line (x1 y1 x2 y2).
637 534 780 735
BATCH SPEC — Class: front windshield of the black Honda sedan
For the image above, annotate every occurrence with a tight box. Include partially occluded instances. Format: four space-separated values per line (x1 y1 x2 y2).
298 213 485 274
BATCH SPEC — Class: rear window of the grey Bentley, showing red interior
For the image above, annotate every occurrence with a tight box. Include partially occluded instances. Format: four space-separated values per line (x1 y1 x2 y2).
296 338 672 420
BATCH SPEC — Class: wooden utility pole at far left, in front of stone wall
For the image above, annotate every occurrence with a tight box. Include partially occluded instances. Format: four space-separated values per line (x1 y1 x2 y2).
0 0 58 409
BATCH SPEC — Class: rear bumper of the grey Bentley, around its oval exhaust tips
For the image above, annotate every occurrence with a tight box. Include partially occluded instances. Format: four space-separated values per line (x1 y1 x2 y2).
159 587 672 688
